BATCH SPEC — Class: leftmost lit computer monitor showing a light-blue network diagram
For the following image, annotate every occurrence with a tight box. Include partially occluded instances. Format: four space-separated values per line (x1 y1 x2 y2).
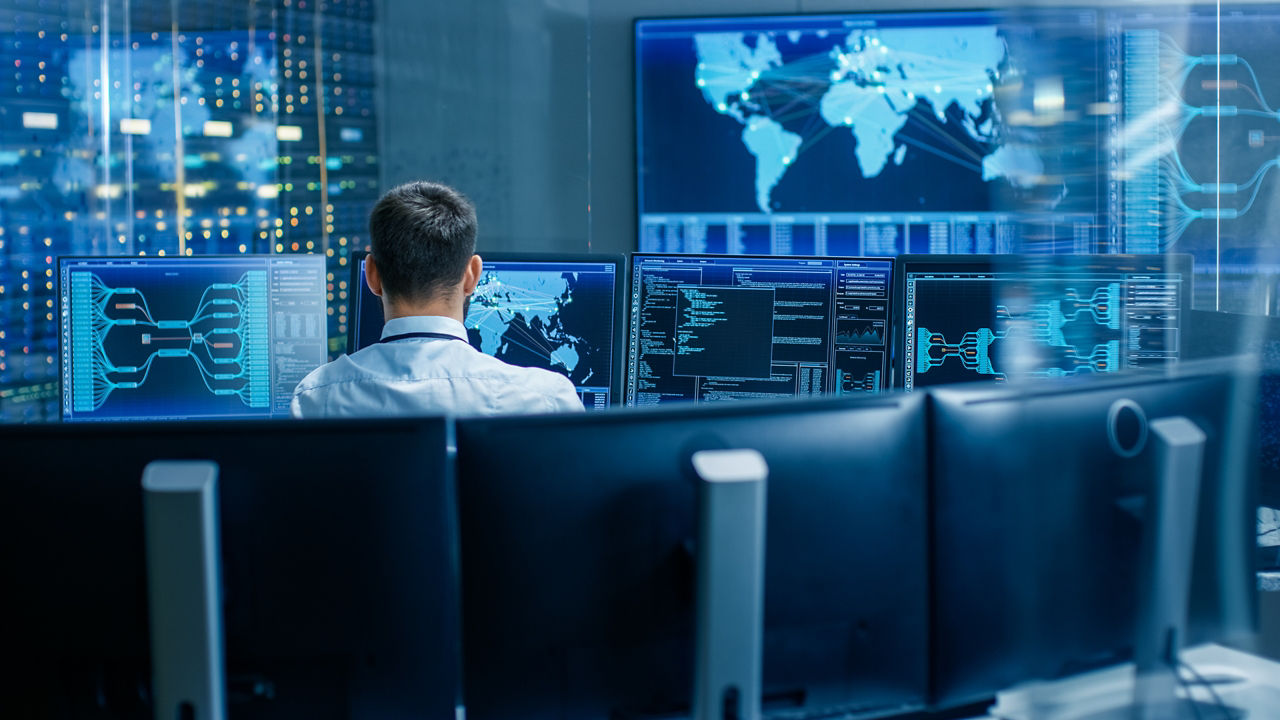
58 255 329 423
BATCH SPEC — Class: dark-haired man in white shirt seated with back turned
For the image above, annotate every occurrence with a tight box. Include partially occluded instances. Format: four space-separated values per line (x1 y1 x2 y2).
292 182 584 418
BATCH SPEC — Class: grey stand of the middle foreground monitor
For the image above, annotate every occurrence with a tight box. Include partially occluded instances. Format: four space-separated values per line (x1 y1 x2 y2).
691 450 768 720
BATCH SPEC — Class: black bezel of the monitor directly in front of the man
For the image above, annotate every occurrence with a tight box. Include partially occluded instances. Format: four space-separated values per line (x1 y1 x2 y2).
347 250 628 406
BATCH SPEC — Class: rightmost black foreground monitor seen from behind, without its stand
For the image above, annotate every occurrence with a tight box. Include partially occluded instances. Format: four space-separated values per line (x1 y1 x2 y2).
929 363 1256 706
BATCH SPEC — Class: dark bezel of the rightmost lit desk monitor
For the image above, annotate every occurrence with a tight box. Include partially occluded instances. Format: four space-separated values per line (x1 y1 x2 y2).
890 252 1194 389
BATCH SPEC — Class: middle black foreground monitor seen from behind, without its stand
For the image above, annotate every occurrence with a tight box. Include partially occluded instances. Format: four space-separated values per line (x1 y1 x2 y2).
457 395 928 719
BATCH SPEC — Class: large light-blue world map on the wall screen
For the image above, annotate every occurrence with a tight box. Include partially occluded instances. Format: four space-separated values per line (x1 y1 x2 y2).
639 24 1044 213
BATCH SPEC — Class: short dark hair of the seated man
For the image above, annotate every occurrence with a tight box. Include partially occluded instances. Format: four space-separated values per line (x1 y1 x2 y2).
369 182 476 301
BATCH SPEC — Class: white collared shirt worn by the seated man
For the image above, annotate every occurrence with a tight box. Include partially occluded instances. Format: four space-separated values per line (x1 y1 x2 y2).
292 315 584 418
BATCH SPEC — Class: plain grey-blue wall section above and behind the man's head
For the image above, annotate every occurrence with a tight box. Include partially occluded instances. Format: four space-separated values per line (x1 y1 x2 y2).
379 0 589 251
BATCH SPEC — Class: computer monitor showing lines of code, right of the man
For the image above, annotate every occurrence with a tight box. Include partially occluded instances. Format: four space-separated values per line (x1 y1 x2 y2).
627 252 893 405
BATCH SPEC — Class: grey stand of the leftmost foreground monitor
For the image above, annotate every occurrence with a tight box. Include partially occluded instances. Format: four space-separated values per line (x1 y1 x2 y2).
142 461 227 720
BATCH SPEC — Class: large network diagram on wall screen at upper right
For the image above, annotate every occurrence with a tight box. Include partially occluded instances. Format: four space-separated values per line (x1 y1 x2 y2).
1105 3 1280 313
